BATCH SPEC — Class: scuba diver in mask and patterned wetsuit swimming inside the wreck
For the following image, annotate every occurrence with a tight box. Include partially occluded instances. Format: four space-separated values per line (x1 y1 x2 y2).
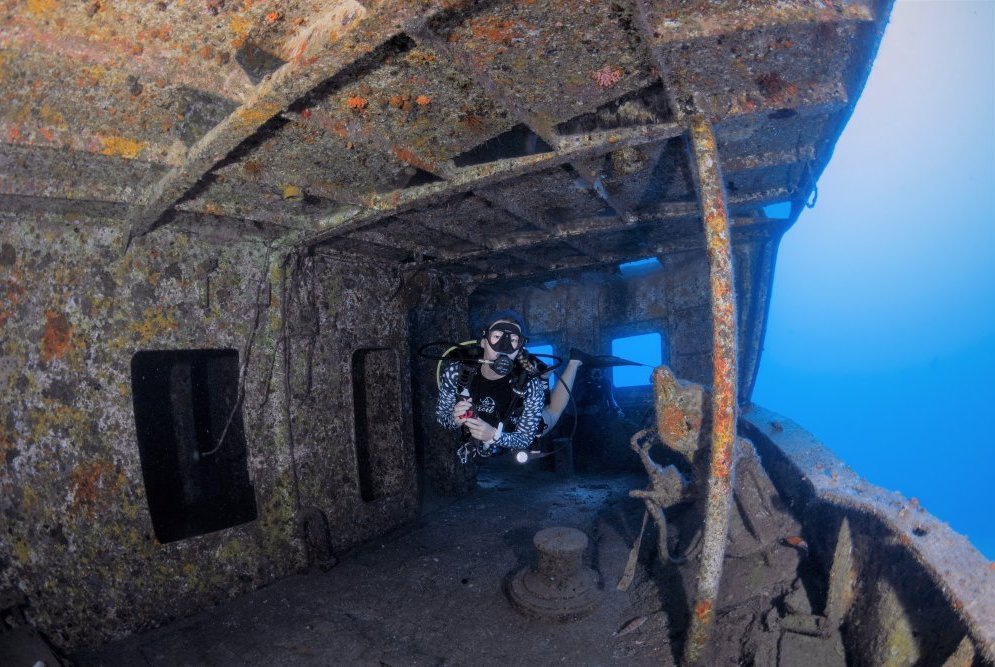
435 310 633 463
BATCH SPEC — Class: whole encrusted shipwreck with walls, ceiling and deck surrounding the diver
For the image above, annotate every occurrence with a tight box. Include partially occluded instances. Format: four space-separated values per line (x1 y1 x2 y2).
0 0 995 665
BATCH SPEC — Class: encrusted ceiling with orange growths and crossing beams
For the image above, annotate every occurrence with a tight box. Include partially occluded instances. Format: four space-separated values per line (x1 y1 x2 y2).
0 0 890 279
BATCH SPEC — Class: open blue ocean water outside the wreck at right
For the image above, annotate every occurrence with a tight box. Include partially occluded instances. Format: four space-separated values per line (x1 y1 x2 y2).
753 0 995 559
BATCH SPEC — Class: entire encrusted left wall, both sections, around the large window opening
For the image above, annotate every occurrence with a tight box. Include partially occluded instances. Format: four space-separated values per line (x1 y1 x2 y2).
0 216 428 650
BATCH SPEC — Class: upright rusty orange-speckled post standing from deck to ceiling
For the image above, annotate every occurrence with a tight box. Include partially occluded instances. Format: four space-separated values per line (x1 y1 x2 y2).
683 115 738 665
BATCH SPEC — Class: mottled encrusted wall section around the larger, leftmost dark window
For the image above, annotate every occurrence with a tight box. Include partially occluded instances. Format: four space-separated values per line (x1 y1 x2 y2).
0 219 302 647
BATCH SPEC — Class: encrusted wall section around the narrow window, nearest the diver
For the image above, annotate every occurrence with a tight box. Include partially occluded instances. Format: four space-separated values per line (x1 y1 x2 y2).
288 257 417 549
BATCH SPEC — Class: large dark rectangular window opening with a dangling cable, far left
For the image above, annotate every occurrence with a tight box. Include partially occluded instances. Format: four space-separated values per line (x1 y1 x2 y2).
131 349 257 543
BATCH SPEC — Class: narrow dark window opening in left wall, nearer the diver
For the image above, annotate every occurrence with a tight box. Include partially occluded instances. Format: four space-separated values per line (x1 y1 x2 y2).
352 348 404 502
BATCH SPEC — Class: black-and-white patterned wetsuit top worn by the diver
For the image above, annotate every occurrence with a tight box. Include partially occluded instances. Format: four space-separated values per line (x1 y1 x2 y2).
435 361 545 449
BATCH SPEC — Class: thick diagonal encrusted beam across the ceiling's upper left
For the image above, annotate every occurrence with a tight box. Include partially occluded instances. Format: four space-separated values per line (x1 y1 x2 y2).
129 0 440 243
